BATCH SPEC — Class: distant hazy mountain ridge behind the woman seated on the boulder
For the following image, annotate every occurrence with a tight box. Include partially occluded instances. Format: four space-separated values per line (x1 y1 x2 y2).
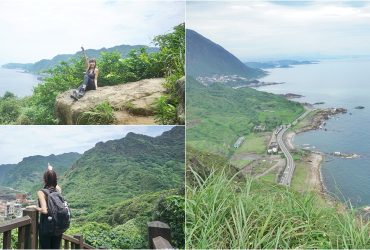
2 45 158 73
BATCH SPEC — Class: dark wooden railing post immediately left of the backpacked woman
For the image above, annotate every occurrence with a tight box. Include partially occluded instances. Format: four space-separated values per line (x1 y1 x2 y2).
23 208 39 249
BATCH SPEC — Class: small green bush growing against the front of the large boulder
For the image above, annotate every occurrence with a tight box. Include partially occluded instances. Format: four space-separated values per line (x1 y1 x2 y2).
77 102 115 125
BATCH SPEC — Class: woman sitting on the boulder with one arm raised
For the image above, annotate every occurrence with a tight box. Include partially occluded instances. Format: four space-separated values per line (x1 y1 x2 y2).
71 47 99 100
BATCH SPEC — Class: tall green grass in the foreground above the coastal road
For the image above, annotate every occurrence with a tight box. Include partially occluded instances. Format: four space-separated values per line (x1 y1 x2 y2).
185 171 370 249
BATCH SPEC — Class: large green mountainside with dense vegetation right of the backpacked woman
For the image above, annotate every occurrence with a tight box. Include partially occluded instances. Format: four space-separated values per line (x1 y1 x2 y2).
60 126 185 248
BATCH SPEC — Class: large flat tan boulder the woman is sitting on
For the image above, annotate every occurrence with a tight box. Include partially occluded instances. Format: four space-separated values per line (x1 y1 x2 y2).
55 78 166 125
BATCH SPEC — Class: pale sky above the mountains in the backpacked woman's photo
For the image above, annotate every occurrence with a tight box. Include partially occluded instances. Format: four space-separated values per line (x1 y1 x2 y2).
0 125 173 164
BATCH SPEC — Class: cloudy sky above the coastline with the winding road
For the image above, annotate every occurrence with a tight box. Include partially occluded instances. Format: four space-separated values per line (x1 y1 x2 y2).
186 0 370 61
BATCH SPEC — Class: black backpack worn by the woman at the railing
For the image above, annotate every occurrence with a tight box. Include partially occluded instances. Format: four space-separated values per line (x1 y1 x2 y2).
40 188 71 236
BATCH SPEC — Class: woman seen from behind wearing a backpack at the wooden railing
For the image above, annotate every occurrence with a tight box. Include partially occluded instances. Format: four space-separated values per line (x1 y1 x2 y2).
30 165 70 249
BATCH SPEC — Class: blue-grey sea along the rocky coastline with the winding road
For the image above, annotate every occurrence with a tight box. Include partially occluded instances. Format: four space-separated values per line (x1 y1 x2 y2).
258 58 370 207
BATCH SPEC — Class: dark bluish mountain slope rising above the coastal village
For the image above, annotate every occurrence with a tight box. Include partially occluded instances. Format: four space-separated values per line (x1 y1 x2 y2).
186 29 265 79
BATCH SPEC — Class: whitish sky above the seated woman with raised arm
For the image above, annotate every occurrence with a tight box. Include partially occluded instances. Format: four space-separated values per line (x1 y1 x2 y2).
0 0 185 65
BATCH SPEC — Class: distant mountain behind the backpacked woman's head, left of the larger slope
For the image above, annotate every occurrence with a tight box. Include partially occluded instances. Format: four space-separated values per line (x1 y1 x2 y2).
0 153 81 192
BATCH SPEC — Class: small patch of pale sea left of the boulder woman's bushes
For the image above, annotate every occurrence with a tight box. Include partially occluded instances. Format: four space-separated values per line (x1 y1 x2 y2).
0 68 40 97
